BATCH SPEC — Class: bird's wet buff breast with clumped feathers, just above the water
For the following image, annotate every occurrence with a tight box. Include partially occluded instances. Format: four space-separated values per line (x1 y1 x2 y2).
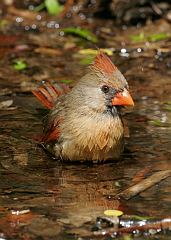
57 115 123 161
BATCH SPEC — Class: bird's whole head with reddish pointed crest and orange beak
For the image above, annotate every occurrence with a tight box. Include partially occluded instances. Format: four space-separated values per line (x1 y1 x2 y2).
73 51 134 116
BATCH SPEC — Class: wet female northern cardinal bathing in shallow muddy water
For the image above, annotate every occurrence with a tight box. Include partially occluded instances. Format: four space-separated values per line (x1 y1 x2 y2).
33 52 134 162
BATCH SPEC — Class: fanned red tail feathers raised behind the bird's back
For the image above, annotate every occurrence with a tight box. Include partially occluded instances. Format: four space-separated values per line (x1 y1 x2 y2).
32 82 69 109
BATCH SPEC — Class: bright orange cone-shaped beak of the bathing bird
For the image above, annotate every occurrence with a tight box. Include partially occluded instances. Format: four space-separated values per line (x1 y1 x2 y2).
112 89 134 106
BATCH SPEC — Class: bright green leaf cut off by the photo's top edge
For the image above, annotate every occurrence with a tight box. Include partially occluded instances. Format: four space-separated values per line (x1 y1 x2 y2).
44 0 64 15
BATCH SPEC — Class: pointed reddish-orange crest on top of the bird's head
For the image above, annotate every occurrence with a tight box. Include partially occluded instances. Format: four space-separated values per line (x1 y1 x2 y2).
91 51 117 74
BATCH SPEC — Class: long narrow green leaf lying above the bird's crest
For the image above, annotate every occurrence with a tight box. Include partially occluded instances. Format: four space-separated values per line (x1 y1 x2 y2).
63 27 98 43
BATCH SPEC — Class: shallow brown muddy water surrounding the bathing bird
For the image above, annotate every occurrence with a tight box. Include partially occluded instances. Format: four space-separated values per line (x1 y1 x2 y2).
0 4 171 239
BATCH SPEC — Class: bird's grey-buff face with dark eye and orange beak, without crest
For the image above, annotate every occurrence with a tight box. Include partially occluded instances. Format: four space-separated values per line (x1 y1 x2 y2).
77 70 134 115
